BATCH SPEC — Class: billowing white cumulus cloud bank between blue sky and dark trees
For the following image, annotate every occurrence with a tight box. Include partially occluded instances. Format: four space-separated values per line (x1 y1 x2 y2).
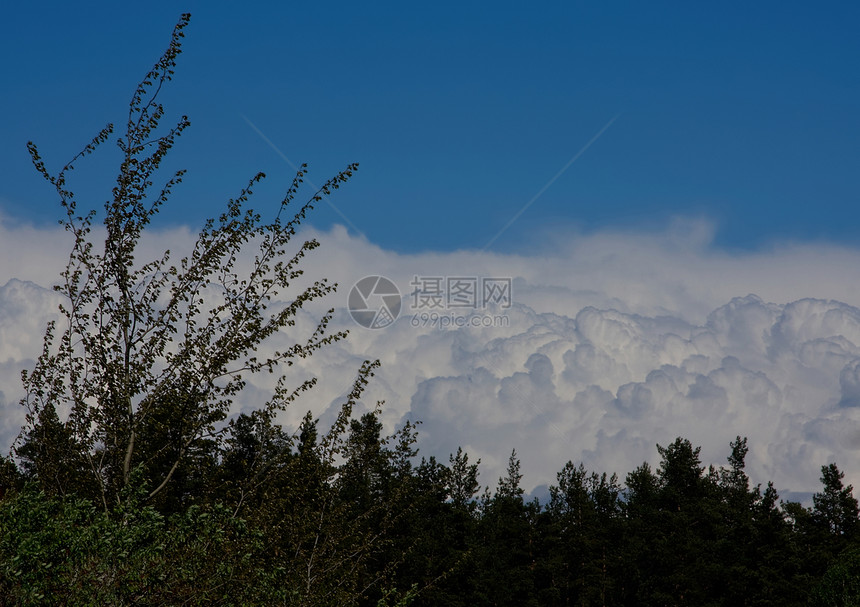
5 214 860 492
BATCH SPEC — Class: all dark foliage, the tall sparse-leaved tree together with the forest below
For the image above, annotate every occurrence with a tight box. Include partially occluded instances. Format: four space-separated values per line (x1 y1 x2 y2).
0 15 860 607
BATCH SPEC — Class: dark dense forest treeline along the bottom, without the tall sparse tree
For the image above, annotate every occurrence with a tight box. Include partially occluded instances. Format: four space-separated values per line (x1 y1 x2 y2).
0 413 860 606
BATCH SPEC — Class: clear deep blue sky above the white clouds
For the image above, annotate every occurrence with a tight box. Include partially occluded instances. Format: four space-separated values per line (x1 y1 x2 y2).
0 2 860 252
